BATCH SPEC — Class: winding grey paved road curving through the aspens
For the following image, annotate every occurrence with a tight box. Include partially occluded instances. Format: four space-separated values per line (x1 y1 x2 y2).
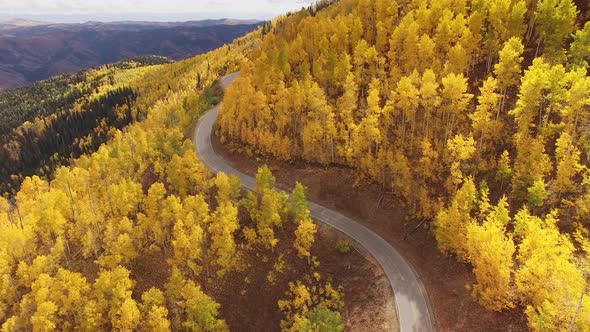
194 73 435 332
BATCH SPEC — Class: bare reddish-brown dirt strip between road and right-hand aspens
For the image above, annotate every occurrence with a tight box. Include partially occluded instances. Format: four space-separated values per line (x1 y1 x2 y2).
213 137 527 331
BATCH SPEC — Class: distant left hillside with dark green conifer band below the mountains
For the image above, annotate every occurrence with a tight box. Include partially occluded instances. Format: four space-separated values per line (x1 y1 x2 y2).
0 56 176 192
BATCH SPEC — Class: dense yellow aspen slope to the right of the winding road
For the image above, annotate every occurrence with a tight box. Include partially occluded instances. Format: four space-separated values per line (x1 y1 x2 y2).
218 0 590 331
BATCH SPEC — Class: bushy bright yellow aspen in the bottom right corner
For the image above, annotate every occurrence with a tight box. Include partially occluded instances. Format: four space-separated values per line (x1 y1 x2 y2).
514 209 585 331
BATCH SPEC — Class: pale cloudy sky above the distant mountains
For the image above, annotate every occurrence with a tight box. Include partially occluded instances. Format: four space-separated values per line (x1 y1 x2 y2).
0 0 312 23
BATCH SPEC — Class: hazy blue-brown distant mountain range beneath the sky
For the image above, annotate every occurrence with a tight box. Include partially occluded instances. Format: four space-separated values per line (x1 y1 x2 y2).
0 19 262 90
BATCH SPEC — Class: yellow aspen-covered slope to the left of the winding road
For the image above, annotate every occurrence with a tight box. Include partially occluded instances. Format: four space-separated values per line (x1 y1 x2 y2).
0 24 360 331
